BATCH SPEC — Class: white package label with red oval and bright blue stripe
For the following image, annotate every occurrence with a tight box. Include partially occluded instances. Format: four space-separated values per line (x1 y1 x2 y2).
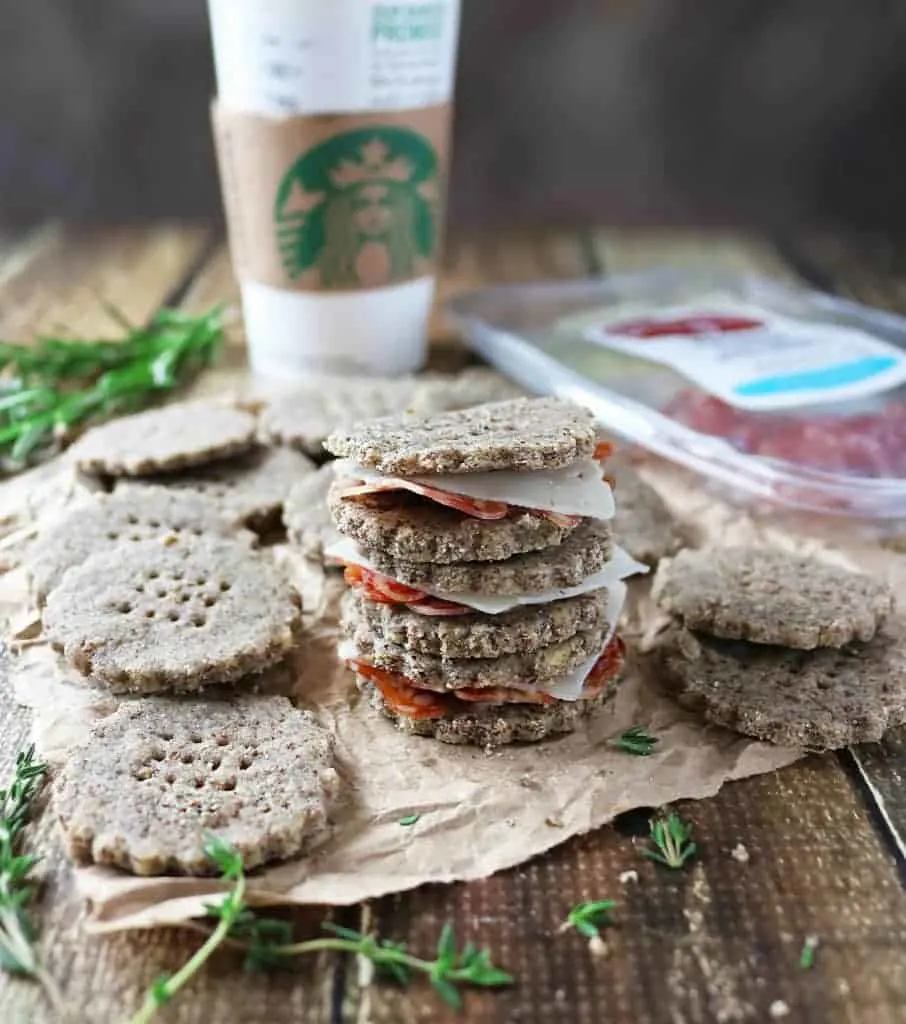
586 303 906 411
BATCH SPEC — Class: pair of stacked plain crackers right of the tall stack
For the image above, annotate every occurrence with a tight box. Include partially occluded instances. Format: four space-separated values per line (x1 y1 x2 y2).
653 547 906 750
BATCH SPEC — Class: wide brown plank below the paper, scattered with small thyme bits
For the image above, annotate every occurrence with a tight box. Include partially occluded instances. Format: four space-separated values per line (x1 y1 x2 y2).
360 758 906 1024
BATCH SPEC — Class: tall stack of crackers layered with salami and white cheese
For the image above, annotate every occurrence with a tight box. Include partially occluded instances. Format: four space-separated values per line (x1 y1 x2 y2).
319 398 639 746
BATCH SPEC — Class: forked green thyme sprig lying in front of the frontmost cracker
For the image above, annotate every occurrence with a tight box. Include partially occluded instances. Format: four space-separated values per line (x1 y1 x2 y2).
130 839 513 1024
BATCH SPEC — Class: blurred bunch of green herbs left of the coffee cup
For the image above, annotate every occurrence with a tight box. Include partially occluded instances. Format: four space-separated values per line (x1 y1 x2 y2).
0 309 223 467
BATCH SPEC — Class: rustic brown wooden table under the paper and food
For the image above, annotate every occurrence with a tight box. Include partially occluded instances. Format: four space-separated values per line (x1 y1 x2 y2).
0 225 906 1024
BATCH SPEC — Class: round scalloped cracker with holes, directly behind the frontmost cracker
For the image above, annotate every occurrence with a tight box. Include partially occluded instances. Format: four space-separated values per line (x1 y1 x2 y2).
44 537 301 693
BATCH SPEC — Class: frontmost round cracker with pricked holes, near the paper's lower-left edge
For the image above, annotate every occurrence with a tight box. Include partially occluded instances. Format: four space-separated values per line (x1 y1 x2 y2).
55 696 339 876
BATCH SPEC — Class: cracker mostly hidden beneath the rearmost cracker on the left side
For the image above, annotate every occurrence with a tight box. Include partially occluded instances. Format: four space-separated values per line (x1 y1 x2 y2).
117 447 315 530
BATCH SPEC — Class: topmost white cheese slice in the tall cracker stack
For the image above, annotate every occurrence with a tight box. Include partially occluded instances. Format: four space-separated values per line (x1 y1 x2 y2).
336 459 614 519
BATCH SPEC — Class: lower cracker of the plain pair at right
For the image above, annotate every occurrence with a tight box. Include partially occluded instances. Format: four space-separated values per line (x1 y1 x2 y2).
657 623 906 750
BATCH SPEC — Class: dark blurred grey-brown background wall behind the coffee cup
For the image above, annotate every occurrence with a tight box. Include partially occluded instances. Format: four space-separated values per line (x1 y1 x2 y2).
0 0 906 232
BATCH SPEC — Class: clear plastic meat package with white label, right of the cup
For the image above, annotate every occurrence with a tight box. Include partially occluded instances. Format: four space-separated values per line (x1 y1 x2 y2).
449 269 906 526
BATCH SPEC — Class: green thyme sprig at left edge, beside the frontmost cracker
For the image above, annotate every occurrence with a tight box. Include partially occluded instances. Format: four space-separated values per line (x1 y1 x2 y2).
0 746 61 1010
